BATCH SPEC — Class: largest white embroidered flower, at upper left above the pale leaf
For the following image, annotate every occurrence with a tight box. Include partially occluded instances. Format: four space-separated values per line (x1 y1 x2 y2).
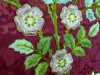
14 4 44 35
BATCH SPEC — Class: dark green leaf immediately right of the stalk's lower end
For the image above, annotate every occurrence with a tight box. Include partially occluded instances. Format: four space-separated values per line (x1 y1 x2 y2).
64 34 75 49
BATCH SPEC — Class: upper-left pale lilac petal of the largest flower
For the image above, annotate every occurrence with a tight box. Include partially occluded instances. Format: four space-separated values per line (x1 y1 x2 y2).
16 4 31 15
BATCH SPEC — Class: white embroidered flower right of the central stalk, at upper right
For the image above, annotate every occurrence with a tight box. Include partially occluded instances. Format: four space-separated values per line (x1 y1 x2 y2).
60 5 82 30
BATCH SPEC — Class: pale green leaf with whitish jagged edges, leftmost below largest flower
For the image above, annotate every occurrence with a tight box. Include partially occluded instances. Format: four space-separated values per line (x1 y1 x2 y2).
9 39 33 55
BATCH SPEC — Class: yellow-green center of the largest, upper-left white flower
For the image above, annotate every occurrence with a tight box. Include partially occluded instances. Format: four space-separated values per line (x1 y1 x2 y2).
24 13 36 27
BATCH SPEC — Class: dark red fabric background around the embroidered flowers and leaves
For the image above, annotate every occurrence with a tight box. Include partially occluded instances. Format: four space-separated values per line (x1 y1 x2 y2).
0 0 100 75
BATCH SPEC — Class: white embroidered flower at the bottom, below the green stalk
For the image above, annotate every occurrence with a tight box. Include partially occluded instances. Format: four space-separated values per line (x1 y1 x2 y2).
50 49 73 75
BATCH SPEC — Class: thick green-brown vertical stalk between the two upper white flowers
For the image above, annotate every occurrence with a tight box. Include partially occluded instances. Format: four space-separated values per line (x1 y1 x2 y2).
48 3 60 50
